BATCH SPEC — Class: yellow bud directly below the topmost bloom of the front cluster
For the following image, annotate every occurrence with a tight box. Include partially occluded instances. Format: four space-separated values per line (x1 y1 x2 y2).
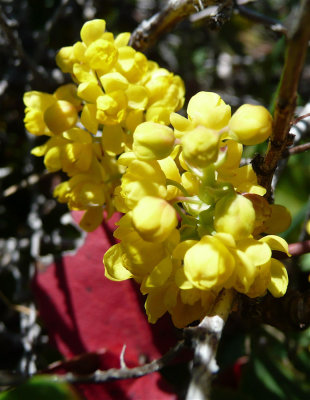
181 125 220 168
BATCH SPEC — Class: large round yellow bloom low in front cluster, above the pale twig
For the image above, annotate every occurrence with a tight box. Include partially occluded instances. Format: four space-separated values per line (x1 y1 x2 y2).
184 235 235 290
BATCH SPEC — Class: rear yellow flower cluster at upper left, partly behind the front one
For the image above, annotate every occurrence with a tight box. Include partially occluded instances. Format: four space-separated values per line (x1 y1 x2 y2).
24 19 184 231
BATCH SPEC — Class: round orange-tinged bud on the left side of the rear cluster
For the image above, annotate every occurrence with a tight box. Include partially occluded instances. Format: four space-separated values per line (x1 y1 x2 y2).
44 100 78 134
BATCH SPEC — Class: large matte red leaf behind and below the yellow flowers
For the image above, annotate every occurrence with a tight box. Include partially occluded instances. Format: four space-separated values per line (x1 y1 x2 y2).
33 211 177 400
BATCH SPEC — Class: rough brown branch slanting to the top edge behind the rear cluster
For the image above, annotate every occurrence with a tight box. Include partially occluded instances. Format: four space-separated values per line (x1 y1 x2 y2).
129 0 232 51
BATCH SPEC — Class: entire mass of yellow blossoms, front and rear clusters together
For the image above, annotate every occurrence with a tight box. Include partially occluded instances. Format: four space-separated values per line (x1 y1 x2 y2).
24 20 290 328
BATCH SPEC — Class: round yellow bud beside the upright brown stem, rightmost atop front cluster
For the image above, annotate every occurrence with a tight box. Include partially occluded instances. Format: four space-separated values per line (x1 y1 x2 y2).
228 104 272 145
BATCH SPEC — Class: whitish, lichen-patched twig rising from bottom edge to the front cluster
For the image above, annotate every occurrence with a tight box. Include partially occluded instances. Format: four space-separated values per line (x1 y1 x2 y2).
184 289 236 400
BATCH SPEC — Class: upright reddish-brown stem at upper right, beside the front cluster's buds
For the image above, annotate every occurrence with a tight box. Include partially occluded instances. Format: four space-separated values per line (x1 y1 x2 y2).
253 0 310 199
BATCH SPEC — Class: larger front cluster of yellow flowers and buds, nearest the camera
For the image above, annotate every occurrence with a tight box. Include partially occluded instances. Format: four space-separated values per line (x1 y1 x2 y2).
104 92 290 328
